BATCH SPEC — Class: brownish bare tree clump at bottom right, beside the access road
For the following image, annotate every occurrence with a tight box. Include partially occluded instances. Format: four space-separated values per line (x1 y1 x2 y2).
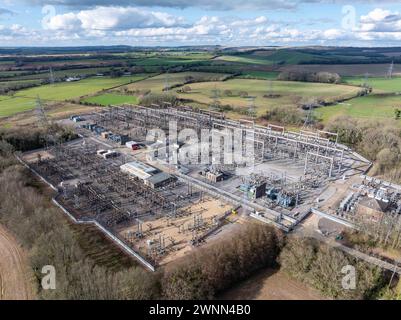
278 237 388 299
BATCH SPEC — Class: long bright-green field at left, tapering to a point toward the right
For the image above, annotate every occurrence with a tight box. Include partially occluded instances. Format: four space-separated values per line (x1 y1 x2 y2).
16 75 146 101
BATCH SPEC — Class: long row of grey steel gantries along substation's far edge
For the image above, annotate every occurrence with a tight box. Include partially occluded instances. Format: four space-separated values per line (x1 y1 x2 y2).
97 105 347 177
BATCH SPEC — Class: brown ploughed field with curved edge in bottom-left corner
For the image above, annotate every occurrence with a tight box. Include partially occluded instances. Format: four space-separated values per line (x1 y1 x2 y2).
0 225 34 300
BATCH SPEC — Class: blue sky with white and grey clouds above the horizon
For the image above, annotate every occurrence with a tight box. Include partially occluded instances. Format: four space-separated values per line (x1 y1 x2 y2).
0 0 401 46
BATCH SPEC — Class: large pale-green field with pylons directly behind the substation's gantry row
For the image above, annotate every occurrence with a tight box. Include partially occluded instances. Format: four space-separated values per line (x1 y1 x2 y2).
179 79 360 115
